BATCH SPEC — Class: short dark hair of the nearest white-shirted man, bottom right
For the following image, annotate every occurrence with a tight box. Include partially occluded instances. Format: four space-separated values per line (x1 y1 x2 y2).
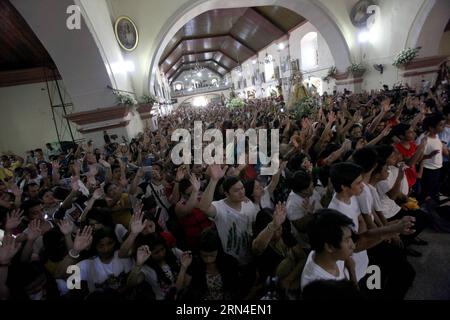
307 209 354 252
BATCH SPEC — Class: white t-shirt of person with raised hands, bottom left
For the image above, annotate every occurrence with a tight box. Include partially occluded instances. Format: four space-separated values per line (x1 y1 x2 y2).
78 251 133 292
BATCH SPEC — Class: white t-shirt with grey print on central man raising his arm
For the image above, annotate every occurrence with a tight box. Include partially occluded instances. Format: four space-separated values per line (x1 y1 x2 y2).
212 199 258 265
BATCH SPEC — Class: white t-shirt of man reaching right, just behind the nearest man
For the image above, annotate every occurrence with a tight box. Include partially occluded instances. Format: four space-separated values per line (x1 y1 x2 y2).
328 193 369 281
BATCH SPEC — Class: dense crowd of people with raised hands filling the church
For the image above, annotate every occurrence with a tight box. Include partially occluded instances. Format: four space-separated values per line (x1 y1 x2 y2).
0 83 450 301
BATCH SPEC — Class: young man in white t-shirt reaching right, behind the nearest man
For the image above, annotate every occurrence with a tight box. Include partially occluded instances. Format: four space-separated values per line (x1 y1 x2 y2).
328 162 415 287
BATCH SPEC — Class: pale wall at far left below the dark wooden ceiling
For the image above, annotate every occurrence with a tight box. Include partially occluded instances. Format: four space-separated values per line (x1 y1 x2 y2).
0 83 79 156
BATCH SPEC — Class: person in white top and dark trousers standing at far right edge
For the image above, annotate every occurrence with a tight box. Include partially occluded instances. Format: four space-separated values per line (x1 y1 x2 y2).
417 113 449 202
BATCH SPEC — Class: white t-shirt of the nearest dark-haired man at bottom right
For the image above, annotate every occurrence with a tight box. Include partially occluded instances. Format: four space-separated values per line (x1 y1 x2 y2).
300 251 348 290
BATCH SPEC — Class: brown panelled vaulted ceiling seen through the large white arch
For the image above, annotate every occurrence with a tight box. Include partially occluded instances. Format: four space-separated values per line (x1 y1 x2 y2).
159 6 305 81
